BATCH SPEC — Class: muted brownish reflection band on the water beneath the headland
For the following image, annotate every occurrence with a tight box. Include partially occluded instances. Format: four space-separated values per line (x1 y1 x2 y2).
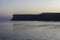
13 23 60 30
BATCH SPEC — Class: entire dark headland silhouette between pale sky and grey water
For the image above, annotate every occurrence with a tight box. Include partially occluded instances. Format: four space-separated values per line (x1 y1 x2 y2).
11 13 60 21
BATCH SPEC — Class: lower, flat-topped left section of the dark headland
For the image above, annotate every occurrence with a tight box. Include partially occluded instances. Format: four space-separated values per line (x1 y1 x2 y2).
12 14 39 21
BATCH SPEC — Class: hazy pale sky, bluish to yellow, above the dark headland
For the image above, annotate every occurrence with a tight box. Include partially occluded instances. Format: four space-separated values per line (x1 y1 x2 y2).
0 0 60 15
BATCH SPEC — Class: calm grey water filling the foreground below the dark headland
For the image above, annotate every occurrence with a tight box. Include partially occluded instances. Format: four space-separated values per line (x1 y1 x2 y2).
0 21 60 40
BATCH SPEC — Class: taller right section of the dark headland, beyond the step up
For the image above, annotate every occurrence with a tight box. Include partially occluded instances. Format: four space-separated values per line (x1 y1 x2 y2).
40 13 60 21
